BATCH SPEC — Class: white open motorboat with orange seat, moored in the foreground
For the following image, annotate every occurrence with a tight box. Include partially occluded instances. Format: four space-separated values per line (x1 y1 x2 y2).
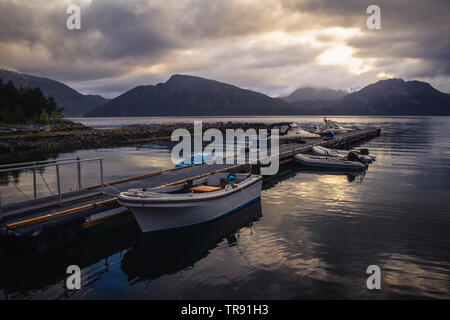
118 173 262 233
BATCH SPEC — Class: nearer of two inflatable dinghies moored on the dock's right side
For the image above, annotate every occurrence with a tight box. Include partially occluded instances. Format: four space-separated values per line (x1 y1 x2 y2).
294 154 367 170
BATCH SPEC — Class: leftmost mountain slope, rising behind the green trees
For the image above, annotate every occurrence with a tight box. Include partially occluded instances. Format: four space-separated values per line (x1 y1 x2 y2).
0 70 109 117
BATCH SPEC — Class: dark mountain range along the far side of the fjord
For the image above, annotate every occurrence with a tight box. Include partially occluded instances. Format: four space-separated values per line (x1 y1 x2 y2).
0 70 450 117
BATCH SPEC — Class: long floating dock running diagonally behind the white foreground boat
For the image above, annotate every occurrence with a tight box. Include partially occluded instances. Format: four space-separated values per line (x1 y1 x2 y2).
0 128 381 251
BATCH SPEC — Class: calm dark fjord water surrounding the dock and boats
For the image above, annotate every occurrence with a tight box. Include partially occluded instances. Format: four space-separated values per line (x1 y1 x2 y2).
0 117 450 299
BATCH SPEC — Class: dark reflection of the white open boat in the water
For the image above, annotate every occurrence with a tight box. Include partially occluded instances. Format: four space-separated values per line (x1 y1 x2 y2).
121 201 262 281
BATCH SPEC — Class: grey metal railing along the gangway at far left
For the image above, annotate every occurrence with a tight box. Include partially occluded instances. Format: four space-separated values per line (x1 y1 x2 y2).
0 157 104 220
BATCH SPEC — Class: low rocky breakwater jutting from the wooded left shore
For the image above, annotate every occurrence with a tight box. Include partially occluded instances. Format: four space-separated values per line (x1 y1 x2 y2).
0 122 269 158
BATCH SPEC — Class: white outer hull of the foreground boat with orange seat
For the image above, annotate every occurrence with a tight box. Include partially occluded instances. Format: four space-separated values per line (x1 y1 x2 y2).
119 180 262 233
